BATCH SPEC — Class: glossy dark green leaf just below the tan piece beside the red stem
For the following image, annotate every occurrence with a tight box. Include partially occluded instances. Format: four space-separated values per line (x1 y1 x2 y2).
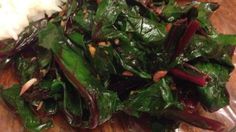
125 78 182 116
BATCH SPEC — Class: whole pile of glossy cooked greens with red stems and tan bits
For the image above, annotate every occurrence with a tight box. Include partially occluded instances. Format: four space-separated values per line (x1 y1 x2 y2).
0 0 236 131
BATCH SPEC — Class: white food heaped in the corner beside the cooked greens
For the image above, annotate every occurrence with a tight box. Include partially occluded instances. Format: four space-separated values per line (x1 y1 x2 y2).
0 0 66 40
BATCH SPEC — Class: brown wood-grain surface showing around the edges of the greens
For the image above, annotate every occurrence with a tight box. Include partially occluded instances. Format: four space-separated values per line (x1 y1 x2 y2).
0 0 236 132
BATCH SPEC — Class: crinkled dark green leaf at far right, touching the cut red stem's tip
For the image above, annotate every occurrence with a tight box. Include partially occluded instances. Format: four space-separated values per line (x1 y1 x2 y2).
194 62 230 111
